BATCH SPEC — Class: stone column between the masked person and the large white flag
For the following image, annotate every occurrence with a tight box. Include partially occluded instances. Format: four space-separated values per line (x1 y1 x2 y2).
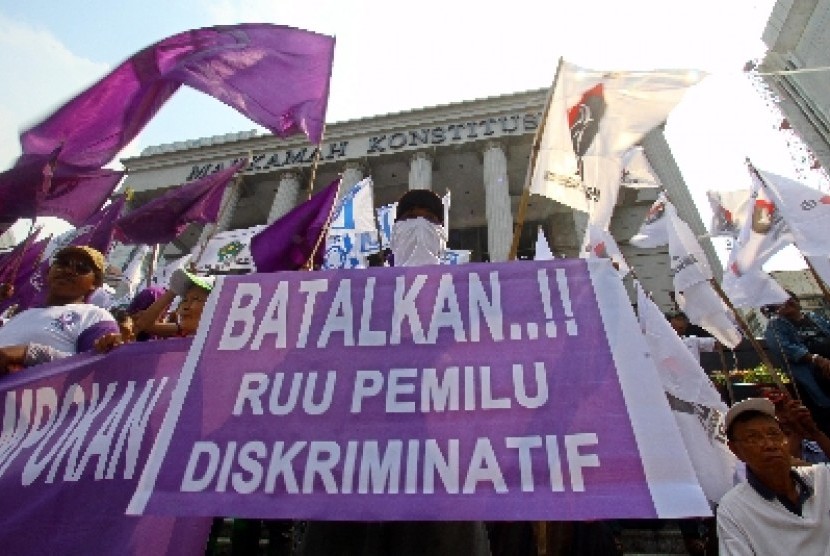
484 141 513 262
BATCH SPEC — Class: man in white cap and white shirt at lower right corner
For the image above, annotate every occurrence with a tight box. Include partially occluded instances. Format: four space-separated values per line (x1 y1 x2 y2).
717 398 830 555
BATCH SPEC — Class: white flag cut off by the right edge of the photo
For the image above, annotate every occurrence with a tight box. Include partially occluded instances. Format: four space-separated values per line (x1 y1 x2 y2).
750 165 830 257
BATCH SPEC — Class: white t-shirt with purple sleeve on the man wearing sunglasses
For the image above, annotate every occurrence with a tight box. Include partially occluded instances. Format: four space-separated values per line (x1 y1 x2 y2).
0 303 118 353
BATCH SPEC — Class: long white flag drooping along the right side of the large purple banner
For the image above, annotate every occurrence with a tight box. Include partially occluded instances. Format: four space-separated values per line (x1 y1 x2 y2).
637 284 737 504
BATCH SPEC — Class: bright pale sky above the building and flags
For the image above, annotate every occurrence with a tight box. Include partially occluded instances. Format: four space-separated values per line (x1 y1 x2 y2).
0 0 820 269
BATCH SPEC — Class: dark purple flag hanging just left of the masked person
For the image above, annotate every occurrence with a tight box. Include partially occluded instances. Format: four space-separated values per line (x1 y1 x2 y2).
251 178 340 272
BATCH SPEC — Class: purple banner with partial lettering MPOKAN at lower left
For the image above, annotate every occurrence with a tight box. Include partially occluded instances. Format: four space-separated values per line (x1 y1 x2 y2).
0 340 211 555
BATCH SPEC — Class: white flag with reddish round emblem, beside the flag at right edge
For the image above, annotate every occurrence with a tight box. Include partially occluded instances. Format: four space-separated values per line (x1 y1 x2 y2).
730 161 793 273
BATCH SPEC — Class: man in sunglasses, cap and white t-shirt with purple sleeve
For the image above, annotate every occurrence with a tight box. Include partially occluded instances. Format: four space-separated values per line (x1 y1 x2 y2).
0 246 118 376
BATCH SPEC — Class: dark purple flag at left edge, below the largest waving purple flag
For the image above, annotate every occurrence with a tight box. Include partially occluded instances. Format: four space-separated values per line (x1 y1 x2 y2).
0 149 124 226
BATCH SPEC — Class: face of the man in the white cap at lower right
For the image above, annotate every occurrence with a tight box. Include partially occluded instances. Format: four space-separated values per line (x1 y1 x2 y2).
729 415 790 473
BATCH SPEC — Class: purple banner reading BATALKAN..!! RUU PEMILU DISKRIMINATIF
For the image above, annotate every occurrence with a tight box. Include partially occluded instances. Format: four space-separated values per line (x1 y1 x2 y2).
135 260 707 520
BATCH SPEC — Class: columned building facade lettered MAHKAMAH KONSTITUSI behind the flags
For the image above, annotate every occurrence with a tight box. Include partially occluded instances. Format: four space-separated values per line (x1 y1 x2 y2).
122 90 719 308
